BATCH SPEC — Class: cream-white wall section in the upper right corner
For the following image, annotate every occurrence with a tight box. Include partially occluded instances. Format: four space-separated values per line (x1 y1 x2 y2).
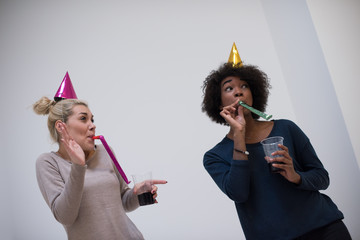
307 0 360 172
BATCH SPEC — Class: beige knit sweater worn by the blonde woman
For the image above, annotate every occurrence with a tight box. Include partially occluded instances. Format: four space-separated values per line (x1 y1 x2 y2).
36 145 144 240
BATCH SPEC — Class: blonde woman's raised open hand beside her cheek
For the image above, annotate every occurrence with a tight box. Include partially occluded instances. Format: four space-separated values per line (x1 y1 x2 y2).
59 122 85 166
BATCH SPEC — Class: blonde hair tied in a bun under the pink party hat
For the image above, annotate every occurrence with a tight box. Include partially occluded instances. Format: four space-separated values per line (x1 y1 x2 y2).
33 97 88 142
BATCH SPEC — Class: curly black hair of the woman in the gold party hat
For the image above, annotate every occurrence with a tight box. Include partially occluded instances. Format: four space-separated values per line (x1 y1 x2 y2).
201 63 271 125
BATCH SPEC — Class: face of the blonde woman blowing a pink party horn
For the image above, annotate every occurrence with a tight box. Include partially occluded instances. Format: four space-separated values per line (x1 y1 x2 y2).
66 105 96 152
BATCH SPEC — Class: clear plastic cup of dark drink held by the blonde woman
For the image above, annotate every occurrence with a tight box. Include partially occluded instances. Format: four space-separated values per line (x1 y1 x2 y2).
132 172 155 206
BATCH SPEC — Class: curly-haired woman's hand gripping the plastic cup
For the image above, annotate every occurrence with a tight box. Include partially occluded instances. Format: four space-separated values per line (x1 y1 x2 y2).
269 144 301 184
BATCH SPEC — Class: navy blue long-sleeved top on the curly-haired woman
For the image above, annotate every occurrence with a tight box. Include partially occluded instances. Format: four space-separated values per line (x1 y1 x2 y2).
204 120 344 240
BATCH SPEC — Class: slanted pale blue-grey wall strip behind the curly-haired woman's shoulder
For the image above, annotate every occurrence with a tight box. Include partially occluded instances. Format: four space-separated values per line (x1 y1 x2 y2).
262 0 360 239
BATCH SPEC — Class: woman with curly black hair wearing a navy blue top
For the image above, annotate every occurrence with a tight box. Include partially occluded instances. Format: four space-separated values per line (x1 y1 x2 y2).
202 51 351 240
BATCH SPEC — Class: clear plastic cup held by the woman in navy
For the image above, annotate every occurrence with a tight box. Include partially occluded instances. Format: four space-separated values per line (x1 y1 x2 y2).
261 136 284 173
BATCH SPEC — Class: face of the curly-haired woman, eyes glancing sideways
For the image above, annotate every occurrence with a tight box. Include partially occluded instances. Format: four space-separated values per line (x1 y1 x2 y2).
220 76 253 107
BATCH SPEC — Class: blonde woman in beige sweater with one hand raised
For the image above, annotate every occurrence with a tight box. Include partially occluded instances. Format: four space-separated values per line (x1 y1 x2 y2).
33 76 166 240
